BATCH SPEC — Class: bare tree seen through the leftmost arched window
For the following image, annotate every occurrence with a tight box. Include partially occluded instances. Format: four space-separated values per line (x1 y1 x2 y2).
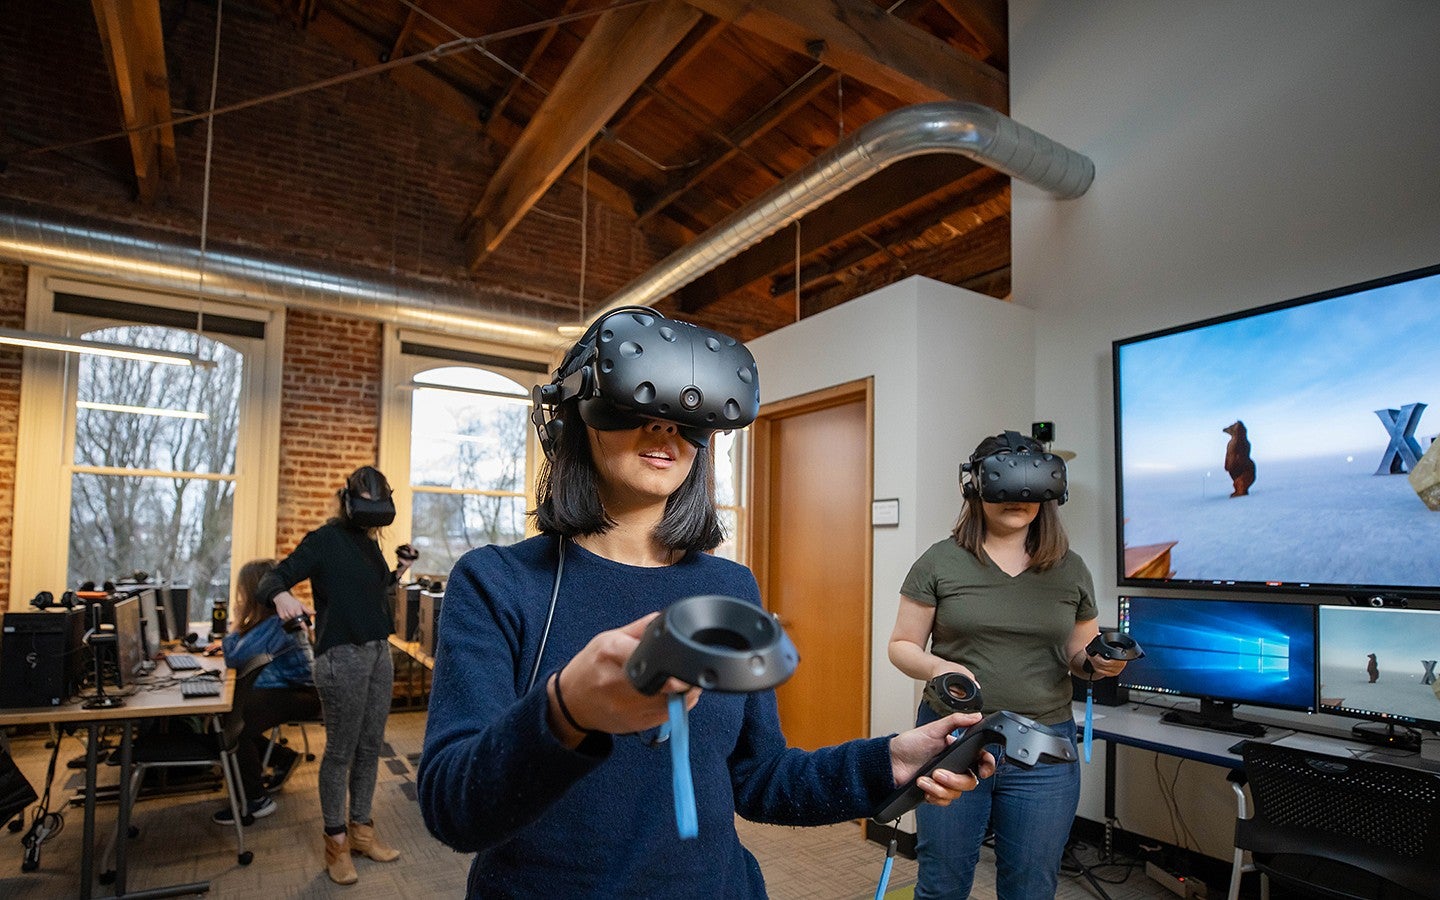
66 325 243 621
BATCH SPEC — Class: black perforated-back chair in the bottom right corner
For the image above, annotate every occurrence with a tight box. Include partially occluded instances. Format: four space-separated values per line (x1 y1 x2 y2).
1230 740 1440 900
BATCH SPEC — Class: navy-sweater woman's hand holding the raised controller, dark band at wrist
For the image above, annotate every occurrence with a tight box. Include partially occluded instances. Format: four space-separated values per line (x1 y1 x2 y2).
546 612 700 747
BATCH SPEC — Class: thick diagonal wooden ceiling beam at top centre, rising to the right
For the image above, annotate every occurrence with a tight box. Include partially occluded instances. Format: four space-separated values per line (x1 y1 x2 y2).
467 0 700 269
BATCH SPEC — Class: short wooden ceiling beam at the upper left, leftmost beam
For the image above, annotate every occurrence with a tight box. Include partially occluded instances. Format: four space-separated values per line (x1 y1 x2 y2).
91 0 179 203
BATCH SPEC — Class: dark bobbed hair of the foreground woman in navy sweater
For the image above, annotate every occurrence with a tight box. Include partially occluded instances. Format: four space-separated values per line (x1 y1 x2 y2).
531 402 724 552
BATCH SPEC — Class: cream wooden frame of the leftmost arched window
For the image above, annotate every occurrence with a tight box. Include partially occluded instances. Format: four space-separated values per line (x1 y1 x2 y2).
10 266 285 608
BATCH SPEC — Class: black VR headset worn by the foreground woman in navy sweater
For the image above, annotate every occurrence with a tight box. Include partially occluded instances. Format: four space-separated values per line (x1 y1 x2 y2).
530 307 760 456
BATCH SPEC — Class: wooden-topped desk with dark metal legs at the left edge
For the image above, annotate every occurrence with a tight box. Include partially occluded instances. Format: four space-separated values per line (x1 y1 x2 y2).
0 657 235 900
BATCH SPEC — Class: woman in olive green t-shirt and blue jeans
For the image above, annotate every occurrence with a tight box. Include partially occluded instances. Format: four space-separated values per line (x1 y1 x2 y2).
890 435 1125 900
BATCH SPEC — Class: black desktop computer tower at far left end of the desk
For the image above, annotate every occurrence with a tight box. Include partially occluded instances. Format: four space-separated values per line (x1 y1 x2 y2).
0 606 86 708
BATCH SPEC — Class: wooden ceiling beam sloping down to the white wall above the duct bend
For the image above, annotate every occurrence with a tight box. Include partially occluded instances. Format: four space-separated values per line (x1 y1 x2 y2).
688 0 1009 112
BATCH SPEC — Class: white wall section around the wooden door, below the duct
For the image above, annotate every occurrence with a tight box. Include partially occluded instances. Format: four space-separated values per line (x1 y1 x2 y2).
746 278 1034 734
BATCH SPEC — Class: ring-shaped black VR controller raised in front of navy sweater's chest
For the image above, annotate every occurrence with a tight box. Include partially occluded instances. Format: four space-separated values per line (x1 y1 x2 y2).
625 593 801 694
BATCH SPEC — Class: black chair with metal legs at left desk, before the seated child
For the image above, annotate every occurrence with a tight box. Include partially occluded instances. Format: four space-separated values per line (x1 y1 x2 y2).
101 654 271 873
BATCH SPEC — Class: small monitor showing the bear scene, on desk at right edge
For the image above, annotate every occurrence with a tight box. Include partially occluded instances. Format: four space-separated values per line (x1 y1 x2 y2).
1320 606 1440 750
